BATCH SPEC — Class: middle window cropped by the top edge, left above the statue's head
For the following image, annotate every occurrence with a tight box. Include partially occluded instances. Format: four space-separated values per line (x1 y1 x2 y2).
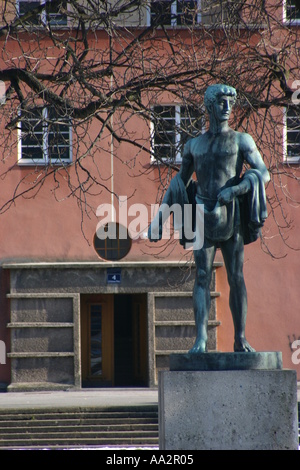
151 0 200 26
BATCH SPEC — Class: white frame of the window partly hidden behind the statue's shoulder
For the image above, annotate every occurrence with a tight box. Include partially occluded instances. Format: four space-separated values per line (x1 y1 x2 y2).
150 103 206 164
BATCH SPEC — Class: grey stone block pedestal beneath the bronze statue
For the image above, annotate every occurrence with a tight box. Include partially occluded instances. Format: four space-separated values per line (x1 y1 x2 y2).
159 353 298 450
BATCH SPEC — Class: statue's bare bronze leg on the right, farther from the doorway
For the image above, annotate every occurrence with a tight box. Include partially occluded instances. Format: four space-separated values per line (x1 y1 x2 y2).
221 233 255 352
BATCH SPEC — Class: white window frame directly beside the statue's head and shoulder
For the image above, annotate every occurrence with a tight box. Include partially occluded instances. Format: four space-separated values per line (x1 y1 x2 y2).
150 103 206 164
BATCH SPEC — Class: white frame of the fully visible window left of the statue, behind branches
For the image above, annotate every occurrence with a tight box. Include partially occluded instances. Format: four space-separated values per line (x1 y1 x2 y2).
18 108 73 166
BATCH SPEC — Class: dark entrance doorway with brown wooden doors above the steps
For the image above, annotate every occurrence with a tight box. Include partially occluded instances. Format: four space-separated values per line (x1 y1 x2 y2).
81 294 148 387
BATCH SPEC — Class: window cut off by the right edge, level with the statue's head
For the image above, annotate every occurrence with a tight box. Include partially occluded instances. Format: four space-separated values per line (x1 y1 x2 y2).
285 109 300 163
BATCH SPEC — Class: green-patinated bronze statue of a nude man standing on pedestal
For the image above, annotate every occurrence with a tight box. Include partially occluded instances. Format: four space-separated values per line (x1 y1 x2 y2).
149 85 270 354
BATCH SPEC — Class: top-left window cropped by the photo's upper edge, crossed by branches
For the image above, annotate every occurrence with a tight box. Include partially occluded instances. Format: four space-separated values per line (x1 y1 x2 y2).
17 0 68 26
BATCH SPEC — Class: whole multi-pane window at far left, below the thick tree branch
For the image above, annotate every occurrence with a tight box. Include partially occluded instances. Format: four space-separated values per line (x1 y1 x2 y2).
19 108 72 165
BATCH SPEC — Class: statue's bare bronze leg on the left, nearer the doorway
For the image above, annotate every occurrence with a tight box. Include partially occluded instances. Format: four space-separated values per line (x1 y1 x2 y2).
189 246 216 354
